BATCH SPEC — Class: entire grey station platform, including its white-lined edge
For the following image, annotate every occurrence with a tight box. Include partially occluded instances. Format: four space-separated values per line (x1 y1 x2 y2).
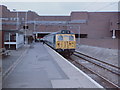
2 43 103 88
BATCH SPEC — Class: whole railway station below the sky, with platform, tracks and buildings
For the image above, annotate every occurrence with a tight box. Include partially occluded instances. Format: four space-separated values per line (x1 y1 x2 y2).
0 2 120 90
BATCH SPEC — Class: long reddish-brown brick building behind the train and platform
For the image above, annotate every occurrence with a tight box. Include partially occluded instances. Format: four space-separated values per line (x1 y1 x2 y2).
0 6 120 49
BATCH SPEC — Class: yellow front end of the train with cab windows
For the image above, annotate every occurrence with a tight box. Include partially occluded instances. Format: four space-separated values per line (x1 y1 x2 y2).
56 32 76 56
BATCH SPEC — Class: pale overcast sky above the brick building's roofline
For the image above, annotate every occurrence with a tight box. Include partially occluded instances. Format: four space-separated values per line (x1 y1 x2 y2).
1 0 118 15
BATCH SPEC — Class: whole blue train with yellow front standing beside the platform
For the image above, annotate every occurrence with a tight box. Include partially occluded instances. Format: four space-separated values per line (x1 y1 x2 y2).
43 30 76 56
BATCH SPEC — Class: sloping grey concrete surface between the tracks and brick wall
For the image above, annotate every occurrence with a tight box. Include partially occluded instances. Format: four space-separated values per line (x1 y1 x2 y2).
76 45 118 66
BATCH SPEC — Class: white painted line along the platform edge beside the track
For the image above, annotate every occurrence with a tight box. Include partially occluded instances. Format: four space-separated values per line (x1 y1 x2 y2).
46 45 104 88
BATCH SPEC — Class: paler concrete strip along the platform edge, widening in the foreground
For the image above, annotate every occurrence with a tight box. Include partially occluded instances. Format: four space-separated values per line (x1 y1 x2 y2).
46 46 103 88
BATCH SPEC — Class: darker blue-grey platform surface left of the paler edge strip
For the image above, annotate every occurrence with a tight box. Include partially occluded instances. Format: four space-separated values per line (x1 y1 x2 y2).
3 43 67 88
